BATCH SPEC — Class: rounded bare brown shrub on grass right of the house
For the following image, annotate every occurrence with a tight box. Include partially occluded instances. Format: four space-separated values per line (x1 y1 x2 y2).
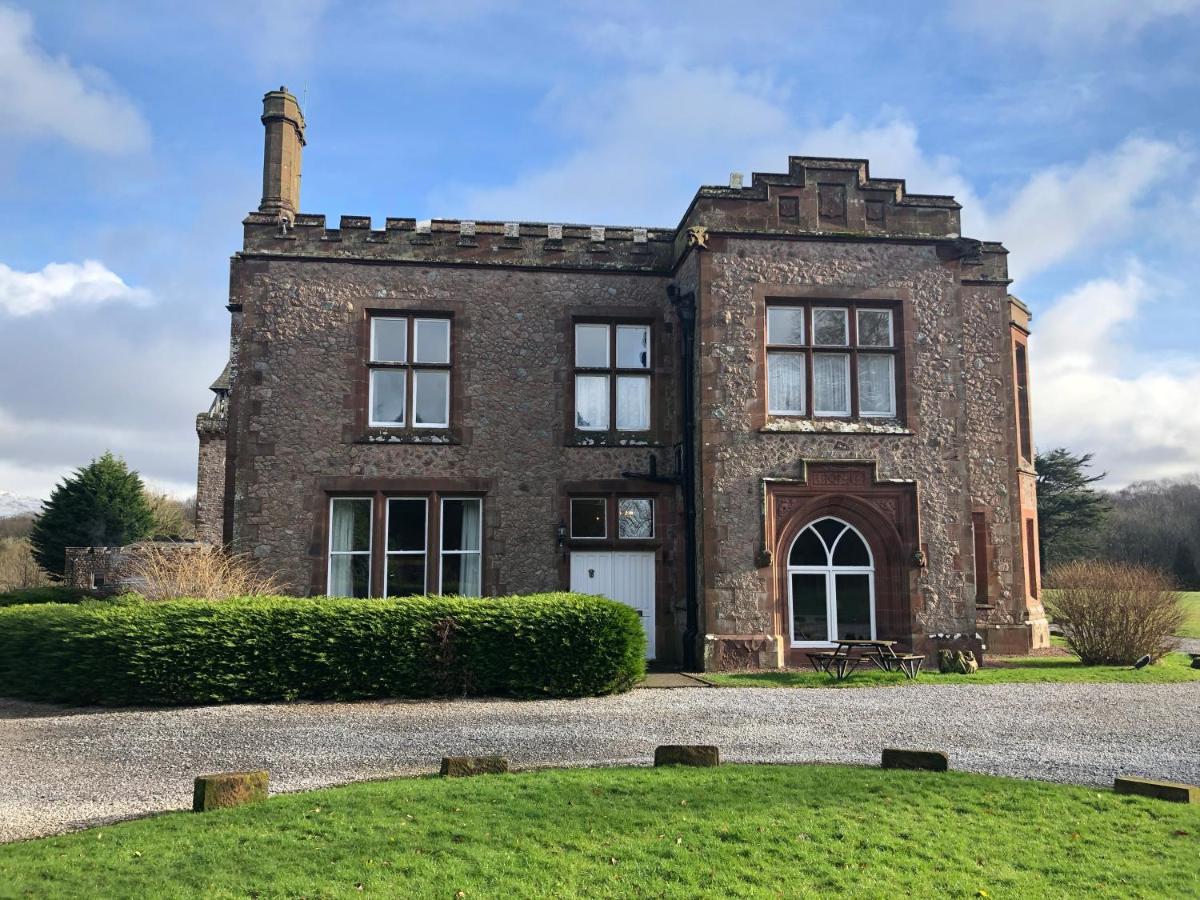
1046 560 1184 666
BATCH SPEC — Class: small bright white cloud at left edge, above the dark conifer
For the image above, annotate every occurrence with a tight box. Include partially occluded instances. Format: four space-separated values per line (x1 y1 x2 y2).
0 259 150 316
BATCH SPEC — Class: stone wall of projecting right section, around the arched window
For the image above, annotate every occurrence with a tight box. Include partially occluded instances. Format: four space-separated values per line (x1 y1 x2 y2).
700 235 1015 662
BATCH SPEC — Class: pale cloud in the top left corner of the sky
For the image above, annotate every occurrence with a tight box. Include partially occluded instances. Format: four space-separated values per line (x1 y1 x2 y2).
0 6 150 154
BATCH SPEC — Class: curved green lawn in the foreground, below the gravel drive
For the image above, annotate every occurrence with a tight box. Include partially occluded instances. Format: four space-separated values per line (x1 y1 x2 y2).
0 766 1200 898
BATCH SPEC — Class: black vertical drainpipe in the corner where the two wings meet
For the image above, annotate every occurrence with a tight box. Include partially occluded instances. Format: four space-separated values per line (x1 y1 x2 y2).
667 286 700 672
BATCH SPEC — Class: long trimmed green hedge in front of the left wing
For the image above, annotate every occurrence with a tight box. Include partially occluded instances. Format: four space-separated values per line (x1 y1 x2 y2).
0 594 646 706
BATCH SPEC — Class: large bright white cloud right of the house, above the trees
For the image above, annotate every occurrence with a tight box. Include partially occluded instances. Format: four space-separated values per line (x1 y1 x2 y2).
1030 264 1200 486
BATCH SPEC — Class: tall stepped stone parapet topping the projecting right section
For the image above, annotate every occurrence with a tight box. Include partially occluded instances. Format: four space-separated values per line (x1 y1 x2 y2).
679 156 961 240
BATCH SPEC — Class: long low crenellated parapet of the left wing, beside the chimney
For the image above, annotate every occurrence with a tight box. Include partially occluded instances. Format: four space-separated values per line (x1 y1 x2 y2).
242 212 674 271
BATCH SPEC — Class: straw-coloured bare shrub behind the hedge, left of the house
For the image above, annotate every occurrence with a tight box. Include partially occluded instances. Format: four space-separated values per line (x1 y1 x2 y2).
125 544 280 600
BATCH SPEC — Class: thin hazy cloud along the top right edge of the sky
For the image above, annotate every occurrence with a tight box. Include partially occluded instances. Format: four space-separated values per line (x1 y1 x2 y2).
953 0 1200 48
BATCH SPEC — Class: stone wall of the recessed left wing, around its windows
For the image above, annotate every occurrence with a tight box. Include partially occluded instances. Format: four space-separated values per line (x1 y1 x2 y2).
230 256 683 656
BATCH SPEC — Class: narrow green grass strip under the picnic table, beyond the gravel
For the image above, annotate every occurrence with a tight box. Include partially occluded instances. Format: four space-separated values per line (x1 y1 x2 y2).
704 653 1200 688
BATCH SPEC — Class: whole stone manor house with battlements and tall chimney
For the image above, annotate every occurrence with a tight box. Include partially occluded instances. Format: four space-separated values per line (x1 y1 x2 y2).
197 88 1048 670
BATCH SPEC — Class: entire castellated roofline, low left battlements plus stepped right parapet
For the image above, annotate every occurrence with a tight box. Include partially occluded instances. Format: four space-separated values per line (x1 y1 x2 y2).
244 156 1007 272
